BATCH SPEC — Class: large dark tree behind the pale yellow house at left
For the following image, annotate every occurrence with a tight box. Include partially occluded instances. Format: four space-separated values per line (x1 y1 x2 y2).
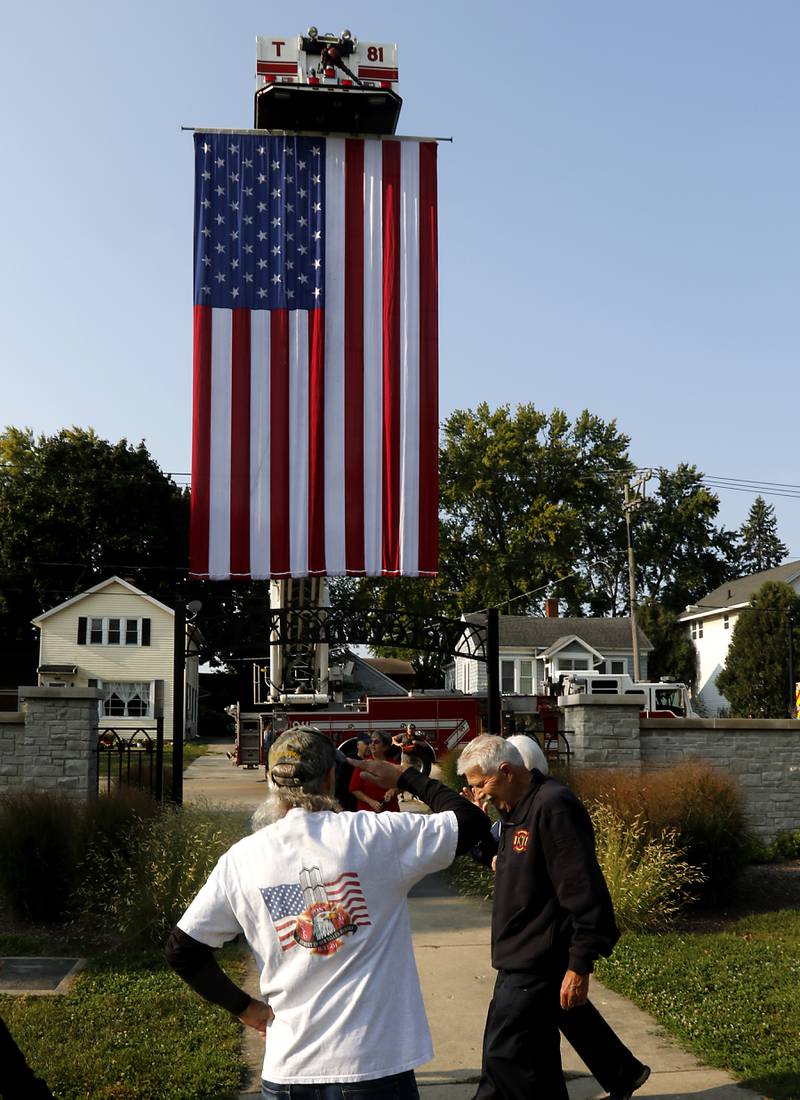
0 428 188 683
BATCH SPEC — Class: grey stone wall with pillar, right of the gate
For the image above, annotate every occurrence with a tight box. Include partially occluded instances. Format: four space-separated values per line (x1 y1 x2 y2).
559 695 800 840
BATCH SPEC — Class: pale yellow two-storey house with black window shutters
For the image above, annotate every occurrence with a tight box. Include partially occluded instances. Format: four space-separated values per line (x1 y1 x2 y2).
32 576 199 739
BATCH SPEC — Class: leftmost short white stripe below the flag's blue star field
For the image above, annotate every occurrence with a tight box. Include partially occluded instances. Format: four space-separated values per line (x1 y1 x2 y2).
208 309 233 579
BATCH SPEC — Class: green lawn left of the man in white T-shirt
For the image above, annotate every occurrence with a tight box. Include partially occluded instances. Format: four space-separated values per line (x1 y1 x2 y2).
0 936 244 1100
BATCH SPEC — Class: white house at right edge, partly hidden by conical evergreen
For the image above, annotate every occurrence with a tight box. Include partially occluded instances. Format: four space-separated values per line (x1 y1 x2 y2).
678 561 800 718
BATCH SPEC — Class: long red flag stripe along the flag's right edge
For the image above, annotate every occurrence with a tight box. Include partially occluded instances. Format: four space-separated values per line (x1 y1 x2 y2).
419 142 439 573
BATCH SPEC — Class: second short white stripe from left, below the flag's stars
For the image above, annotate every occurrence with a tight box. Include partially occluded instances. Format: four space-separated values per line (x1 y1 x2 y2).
250 309 271 580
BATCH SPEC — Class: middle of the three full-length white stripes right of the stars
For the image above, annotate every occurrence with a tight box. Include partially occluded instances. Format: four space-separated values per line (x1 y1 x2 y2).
364 141 383 576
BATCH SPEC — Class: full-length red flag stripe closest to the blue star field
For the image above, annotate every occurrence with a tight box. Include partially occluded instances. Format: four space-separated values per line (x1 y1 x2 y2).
344 141 364 573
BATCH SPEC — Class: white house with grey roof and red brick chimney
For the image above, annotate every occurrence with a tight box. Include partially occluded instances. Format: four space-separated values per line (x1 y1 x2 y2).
447 615 653 696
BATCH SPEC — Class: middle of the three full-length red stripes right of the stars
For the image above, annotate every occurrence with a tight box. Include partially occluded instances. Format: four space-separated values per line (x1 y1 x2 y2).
383 141 401 574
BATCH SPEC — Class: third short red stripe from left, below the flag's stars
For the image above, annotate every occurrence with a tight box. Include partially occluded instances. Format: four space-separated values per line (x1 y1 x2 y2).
270 309 291 576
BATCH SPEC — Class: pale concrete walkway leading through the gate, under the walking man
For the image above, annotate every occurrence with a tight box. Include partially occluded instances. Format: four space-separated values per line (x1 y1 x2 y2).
184 745 758 1100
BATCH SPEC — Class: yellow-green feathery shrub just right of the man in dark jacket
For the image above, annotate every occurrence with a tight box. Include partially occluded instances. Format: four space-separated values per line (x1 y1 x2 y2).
592 803 703 932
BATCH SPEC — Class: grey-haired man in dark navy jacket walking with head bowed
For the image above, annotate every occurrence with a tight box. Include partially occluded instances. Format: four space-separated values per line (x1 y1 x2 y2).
459 734 649 1100
